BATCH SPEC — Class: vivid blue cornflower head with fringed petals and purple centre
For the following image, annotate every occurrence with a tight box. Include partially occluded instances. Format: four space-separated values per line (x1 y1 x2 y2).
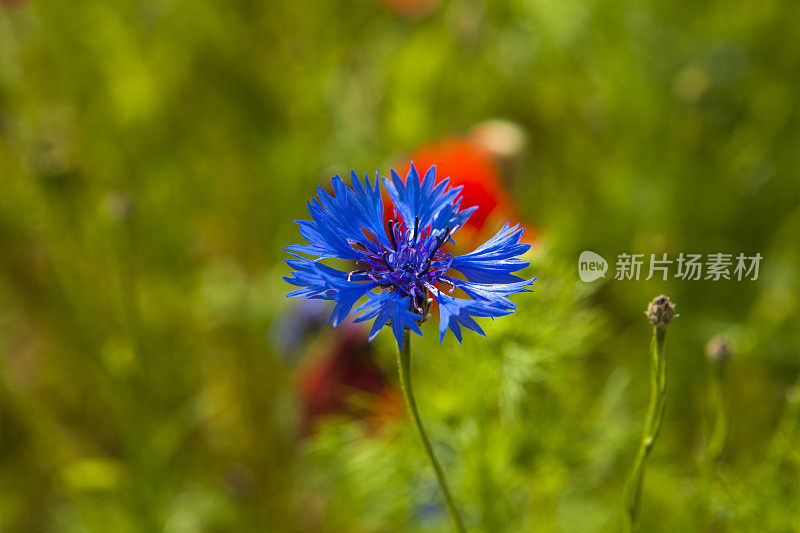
283 164 534 352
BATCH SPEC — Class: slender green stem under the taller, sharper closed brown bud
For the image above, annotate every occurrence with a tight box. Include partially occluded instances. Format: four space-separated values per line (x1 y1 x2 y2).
624 326 667 532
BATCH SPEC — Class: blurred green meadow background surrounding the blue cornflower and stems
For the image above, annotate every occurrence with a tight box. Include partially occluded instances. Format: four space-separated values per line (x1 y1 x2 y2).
0 0 800 532
